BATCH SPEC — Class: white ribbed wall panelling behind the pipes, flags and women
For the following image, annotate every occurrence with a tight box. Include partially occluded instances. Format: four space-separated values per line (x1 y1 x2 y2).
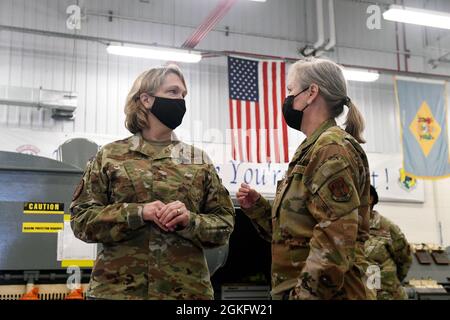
0 0 450 243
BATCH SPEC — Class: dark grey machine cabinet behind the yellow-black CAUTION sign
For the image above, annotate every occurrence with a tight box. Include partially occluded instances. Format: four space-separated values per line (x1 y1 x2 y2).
0 152 87 280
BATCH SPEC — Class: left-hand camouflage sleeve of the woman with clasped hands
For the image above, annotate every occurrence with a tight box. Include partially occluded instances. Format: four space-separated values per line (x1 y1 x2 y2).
70 151 145 243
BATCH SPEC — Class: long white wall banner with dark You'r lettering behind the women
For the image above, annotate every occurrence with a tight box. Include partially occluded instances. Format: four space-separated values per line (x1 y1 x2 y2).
0 129 425 203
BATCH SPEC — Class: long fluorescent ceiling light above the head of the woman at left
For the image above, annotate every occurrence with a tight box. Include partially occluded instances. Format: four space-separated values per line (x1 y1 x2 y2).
106 45 202 63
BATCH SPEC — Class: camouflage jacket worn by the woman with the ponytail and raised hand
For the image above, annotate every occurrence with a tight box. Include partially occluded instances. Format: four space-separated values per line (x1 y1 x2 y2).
244 120 375 299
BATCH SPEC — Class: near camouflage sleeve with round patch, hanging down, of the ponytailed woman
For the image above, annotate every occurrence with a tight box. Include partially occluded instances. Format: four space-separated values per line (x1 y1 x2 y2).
291 147 360 299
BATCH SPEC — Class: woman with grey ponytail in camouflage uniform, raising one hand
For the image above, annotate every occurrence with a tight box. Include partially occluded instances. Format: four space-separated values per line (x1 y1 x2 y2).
237 58 375 299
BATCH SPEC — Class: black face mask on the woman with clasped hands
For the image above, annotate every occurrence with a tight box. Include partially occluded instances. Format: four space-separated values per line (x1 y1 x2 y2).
149 96 186 130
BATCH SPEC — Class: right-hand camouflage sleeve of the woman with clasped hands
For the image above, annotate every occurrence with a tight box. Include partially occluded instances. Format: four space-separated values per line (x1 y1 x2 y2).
177 165 235 248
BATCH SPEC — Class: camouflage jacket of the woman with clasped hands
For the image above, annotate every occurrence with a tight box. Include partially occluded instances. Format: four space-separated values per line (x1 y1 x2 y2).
71 134 235 299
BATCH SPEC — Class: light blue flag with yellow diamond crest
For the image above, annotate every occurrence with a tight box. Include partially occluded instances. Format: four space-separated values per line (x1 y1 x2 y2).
396 79 450 179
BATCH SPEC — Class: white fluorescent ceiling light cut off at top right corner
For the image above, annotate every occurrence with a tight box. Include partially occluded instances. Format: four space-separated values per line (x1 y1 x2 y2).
383 5 450 29
